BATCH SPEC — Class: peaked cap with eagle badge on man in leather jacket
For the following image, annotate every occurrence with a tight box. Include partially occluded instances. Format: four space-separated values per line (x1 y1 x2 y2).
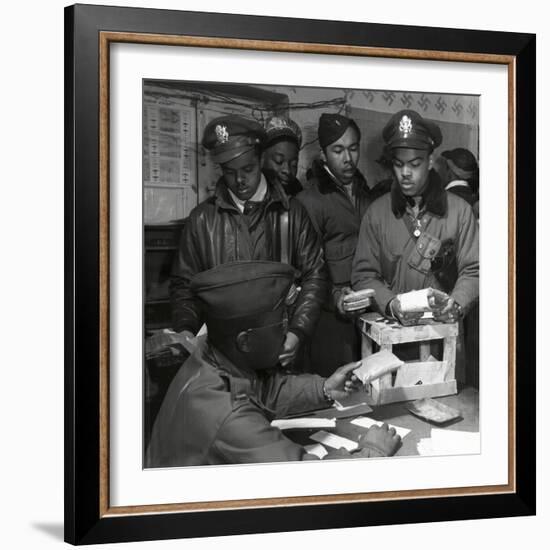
202 115 265 164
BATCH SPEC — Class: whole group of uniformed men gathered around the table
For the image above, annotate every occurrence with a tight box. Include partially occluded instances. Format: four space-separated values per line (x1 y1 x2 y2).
145 106 479 467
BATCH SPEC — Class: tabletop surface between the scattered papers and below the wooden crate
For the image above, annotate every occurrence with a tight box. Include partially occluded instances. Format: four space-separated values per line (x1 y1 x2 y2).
285 387 479 462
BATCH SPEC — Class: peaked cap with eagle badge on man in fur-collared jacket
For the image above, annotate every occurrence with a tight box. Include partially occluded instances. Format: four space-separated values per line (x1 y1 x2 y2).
382 109 443 151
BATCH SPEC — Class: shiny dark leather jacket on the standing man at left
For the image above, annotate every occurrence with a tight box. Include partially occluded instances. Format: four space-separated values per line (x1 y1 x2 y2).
170 179 327 338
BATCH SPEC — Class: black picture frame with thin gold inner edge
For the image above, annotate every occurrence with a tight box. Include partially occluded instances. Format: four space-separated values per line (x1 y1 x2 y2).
65 5 536 544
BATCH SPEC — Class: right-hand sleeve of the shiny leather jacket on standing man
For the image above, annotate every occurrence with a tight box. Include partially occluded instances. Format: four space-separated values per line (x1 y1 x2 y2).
289 199 328 336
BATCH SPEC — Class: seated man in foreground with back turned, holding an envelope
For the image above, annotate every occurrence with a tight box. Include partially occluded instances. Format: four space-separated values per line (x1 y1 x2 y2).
145 261 400 468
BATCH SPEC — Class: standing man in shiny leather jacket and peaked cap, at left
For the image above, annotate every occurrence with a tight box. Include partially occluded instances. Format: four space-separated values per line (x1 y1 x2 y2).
170 111 326 368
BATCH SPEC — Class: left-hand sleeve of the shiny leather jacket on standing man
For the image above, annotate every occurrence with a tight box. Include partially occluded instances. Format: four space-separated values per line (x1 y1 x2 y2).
170 213 206 334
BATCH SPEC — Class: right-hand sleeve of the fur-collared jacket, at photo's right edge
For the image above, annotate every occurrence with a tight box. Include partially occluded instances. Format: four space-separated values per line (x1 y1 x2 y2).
451 201 479 312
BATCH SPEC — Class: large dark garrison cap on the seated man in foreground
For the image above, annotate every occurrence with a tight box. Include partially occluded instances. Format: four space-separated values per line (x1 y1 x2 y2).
191 261 295 325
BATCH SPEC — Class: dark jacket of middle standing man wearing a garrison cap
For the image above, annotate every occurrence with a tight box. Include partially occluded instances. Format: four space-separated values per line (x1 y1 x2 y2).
296 162 376 296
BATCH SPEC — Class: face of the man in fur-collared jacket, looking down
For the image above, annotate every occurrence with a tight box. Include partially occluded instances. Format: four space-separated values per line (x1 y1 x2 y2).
392 148 432 197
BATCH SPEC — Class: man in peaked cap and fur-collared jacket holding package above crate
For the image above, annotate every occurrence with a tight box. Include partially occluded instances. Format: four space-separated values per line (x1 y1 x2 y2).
352 106 479 332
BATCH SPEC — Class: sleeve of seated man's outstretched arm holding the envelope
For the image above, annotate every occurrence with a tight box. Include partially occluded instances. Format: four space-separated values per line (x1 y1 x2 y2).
262 371 329 418
